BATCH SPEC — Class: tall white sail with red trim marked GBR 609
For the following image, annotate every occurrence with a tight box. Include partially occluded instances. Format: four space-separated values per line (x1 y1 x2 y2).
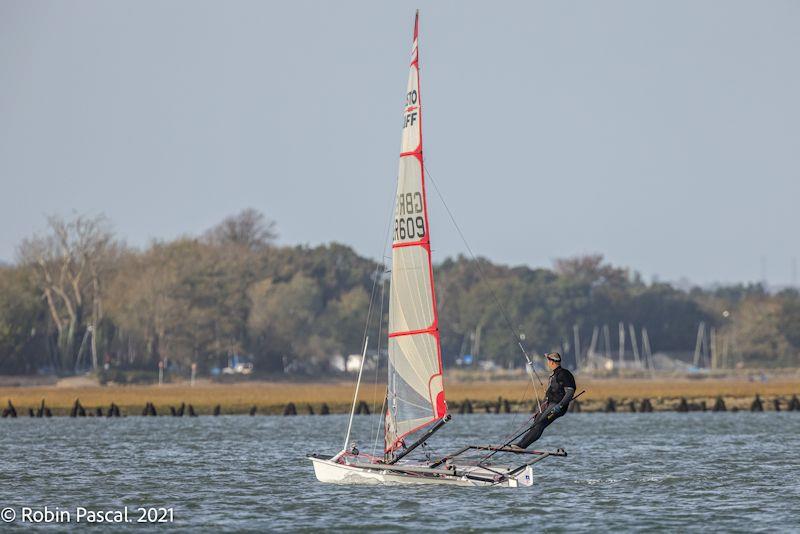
385 13 447 452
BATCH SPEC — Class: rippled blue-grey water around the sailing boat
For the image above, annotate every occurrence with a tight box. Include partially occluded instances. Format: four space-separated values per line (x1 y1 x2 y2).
0 412 800 532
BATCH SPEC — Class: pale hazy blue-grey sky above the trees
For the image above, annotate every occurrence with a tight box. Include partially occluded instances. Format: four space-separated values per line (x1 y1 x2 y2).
0 0 800 284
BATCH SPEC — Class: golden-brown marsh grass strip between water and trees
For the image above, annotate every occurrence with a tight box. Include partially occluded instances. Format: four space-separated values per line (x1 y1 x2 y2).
0 376 800 417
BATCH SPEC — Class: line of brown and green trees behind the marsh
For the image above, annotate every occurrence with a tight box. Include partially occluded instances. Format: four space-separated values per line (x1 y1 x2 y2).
0 209 800 375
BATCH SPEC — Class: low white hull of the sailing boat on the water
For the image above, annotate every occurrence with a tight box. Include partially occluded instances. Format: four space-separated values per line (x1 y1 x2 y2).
308 456 533 488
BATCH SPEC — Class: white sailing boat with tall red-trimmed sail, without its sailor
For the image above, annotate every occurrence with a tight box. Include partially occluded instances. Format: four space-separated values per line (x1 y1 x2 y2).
308 11 566 487
